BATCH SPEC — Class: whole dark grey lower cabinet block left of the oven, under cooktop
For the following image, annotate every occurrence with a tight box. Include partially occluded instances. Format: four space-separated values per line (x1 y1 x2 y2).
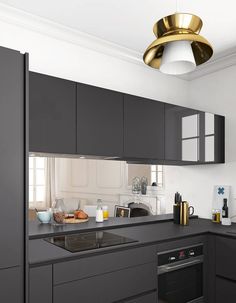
28 245 157 303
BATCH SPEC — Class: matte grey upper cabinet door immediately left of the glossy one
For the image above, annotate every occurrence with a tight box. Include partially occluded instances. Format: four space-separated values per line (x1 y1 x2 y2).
124 95 164 160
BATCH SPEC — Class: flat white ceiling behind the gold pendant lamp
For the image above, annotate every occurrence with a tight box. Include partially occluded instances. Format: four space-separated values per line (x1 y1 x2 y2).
0 0 236 55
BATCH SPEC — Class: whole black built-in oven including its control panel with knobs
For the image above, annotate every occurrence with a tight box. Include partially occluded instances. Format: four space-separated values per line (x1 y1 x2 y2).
158 244 204 303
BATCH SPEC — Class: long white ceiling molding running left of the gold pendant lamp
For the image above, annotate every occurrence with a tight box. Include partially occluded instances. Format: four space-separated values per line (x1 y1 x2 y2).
0 4 143 65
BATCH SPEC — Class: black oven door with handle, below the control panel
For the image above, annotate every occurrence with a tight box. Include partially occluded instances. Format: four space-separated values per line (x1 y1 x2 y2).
158 257 204 303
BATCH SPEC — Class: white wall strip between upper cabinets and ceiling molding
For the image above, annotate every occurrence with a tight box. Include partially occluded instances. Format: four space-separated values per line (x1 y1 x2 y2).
0 21 188 103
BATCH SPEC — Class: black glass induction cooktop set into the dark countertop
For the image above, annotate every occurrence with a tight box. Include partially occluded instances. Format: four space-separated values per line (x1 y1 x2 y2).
45 231 138 253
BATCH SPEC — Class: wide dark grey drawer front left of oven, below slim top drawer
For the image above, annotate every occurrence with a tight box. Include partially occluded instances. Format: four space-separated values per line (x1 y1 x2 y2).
53 263 157 303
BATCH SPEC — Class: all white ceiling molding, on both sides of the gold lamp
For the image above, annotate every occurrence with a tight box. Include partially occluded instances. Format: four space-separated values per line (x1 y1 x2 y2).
0 4 236 81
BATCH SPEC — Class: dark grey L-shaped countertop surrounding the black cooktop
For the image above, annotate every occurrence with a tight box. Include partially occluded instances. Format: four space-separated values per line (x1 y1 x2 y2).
29 215 236 266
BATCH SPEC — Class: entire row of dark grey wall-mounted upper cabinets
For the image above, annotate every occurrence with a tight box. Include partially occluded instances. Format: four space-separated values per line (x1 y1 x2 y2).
29 72 225 165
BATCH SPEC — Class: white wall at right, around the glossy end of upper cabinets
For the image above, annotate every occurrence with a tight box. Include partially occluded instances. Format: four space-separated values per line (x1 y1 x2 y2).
165 66 236 218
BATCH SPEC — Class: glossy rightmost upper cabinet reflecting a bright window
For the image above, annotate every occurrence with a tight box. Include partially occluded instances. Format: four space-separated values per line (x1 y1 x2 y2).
165 104 224 164
